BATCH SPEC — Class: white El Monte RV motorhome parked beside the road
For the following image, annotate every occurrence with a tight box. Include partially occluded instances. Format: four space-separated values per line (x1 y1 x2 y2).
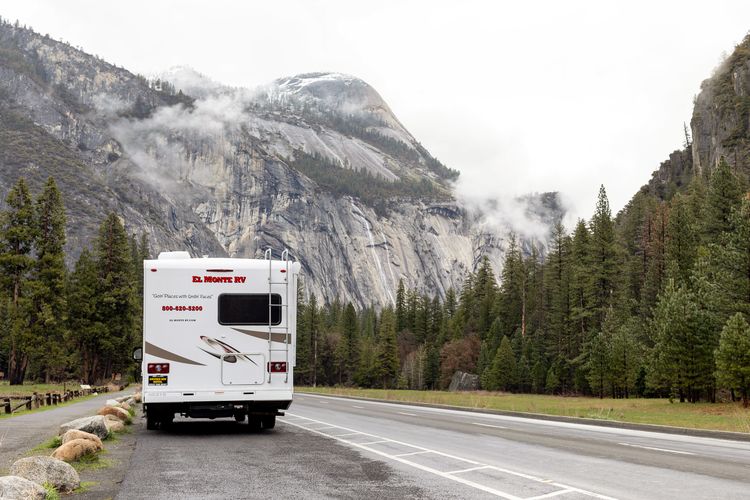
142 249 300 429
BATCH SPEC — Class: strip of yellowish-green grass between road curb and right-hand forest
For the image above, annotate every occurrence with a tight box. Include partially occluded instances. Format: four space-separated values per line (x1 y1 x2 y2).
296 387 750 433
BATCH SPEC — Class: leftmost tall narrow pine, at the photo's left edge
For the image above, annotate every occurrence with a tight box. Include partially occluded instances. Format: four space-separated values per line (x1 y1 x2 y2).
0 177 36 385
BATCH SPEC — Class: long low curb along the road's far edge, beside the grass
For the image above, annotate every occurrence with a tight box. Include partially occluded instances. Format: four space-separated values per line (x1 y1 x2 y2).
296 391 750 442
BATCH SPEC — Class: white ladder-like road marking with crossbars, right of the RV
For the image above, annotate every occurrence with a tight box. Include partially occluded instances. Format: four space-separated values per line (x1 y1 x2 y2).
283 413 615 500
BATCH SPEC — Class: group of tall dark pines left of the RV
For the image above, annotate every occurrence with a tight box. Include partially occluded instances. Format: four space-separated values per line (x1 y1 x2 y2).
0 177 148 385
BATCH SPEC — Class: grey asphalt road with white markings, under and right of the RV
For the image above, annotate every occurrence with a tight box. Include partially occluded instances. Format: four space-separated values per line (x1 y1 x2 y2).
117 394 750 499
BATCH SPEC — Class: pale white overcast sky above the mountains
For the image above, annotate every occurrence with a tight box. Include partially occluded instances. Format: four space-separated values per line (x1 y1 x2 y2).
0 0 750 218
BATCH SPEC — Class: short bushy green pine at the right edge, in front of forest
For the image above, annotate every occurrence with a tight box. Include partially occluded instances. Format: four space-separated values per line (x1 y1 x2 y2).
716 313 750 408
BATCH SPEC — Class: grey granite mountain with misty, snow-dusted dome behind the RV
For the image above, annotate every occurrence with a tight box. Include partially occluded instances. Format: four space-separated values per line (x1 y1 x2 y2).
0 23 560 306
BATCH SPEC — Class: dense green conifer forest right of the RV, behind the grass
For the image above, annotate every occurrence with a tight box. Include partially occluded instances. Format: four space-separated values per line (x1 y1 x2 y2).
295 159 750 404
